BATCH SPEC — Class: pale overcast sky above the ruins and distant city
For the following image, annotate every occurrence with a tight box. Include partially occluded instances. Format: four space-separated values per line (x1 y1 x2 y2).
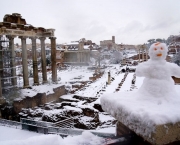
0 0 180 44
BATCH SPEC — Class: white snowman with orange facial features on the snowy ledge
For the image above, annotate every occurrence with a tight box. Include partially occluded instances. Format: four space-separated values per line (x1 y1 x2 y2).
136 42 180 101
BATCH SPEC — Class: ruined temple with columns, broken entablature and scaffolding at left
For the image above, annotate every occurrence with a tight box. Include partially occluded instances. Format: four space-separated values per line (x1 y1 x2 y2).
0 13 57 98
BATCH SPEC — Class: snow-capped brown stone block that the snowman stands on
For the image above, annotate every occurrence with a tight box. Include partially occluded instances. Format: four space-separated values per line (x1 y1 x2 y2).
101 92 180 145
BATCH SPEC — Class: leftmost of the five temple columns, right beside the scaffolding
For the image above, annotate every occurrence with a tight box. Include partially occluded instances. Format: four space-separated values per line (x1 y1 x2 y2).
7 35 17 86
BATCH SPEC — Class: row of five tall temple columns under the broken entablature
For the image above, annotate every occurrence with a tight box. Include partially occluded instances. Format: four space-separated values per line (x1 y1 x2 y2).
2 36 57 88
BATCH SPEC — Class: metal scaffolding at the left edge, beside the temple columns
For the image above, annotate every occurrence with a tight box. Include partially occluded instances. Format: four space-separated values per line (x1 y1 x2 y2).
0 36 17 93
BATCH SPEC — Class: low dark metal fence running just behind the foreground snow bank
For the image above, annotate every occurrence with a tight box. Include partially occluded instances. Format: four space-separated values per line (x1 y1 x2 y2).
0 118 115 138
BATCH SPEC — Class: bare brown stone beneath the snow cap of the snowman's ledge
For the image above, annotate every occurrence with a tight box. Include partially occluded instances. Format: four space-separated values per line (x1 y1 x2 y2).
116 122 180 145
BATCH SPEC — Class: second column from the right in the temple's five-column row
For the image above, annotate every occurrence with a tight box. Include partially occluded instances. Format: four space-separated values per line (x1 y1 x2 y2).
39 37 47 84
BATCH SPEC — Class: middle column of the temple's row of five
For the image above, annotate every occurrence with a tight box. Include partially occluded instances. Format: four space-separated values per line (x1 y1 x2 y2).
30 37 39 85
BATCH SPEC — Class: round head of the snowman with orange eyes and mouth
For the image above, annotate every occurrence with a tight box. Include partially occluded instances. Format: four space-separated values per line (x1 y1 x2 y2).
149 42 168 60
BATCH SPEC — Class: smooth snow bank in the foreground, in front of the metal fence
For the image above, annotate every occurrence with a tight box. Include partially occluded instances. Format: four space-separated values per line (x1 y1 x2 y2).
0 126 106 145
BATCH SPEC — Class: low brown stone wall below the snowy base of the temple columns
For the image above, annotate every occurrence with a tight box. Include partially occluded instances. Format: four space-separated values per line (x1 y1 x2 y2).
13 86 66 114
